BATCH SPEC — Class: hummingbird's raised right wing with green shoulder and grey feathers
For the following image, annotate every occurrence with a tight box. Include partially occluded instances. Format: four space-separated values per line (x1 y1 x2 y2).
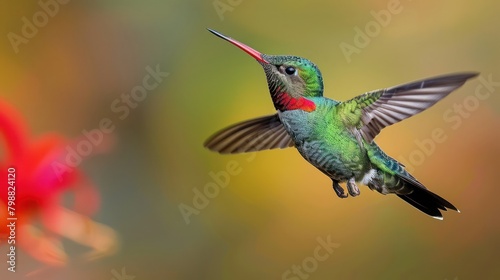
338 72 478 143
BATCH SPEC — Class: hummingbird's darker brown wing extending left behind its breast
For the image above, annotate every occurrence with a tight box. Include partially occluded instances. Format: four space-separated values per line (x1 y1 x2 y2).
204 114 294 154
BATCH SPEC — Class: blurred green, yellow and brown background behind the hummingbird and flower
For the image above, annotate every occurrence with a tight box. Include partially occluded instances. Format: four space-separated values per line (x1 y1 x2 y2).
0 0 500 280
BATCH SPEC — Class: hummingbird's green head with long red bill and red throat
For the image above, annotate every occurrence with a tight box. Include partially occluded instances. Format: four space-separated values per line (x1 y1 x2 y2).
208 29 323 111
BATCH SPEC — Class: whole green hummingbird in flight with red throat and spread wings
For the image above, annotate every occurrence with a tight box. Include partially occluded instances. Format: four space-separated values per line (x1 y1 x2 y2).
204 29 479 220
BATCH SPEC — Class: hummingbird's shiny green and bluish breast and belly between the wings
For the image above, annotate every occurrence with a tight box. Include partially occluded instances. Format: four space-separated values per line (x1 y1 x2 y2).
279 97 371 182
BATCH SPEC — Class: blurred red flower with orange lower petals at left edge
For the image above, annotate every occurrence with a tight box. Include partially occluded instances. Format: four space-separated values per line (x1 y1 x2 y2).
0 101 117 265
